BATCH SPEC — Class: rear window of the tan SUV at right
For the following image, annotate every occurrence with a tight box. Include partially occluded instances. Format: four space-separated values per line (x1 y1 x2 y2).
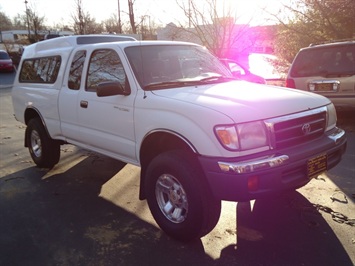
291 45 355 77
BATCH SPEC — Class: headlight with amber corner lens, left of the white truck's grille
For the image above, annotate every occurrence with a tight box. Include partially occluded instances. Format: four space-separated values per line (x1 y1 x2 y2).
215 121 269 150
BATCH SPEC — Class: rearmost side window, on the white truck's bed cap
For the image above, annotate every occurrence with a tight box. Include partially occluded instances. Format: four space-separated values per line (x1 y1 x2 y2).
19 56 61 83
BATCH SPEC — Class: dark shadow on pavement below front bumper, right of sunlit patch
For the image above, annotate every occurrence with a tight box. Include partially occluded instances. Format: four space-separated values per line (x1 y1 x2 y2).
218 191 353 266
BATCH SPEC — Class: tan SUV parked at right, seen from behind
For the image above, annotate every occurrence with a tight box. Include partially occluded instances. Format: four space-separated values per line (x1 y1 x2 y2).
286 40 355 107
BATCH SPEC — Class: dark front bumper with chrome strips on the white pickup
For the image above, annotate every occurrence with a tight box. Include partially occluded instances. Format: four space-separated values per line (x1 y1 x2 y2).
199 128 346 201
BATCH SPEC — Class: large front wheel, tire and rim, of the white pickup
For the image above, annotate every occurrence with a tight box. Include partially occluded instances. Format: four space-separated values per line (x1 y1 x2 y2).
144 151 221 242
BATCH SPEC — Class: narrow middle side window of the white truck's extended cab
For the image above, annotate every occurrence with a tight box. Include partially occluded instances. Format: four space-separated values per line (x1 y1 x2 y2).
68 51 86 90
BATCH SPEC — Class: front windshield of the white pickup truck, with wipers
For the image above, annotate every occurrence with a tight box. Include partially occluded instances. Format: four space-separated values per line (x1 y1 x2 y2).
125 45 234 90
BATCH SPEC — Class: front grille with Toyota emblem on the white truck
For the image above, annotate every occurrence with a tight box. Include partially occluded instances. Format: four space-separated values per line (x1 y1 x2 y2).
273 112 326 149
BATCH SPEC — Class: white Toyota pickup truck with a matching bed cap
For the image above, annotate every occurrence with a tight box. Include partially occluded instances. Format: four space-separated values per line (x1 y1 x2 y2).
12 35 346 241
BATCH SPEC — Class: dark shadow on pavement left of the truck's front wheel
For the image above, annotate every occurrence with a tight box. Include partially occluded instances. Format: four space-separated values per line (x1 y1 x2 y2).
0 154 211 265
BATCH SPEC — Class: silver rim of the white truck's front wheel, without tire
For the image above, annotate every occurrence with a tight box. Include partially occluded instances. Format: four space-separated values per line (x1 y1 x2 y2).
155 174 188 223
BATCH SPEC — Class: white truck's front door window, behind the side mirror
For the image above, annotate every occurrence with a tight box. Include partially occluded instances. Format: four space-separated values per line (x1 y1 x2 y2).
86 49 129 92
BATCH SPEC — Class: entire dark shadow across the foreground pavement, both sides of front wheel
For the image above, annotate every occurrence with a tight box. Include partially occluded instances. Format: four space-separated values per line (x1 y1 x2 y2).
0 153 352 266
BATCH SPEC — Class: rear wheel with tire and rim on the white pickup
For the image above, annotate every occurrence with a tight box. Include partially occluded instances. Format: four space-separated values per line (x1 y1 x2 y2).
26 117 60 168
